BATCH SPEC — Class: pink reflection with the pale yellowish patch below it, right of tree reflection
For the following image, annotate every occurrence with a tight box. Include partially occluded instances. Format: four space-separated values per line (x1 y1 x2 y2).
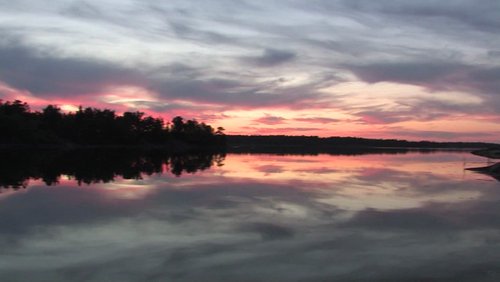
215 152 494 210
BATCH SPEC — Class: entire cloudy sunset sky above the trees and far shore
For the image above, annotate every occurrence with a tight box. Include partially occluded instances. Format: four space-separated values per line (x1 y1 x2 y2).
0 0 500 142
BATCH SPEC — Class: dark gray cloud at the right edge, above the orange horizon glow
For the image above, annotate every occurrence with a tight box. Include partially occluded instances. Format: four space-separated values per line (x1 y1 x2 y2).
346 61 500 114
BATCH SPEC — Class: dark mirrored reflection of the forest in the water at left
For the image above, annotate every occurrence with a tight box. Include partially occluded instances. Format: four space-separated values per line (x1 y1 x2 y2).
0 149 225 189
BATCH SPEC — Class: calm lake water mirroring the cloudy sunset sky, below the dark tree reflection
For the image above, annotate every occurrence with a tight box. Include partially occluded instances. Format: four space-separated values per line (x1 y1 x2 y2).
0 152 500 281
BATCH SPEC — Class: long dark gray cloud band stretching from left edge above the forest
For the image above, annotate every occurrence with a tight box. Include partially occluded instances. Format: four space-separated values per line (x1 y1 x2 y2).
0 41 322 108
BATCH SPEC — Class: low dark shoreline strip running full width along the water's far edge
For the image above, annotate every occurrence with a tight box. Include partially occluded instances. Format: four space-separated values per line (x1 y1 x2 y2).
0 135 494 154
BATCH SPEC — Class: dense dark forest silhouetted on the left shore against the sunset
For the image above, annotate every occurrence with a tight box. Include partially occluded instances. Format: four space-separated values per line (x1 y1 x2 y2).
0 100 225 148
